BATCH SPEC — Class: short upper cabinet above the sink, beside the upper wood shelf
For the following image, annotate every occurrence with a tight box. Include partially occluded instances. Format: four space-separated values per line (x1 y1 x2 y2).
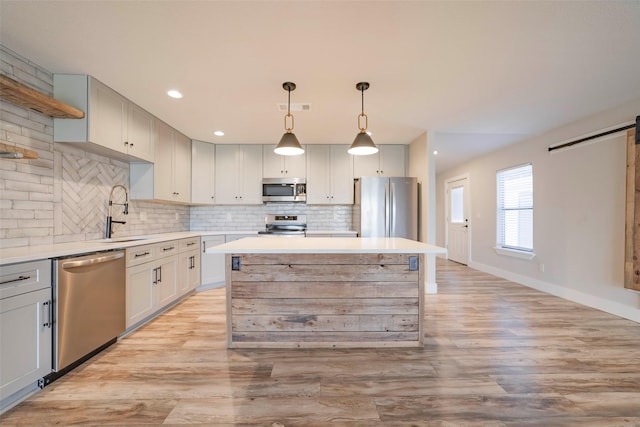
53 74 155 162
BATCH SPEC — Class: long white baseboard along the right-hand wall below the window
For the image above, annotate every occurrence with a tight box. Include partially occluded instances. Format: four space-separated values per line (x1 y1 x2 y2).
469 262 640 323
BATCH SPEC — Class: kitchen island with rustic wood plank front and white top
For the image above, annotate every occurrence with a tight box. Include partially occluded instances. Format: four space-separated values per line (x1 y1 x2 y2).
207 237 446 348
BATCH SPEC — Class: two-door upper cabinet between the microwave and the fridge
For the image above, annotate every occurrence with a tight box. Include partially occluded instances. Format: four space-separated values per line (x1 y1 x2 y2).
307 145 353 205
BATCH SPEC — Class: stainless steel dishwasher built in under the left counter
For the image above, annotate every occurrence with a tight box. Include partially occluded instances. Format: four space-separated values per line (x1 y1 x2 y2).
47 250 126 382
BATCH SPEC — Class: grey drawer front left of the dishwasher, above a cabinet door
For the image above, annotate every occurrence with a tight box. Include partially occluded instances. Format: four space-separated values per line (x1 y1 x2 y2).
0 259 51 299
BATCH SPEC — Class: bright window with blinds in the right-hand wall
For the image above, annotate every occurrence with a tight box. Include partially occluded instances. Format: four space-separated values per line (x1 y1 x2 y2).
496 164 533 252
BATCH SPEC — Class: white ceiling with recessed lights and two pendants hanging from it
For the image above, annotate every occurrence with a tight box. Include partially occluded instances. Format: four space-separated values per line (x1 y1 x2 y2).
0 0 640 171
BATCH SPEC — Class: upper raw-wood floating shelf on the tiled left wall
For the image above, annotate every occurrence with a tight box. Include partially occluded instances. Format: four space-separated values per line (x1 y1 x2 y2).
0 74 84 119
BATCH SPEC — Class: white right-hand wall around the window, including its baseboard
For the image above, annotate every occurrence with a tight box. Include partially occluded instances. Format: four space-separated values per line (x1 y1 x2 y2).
436 99 640 322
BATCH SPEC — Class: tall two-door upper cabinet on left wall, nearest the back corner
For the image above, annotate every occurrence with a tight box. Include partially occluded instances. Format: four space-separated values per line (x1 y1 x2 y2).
129 120 191 203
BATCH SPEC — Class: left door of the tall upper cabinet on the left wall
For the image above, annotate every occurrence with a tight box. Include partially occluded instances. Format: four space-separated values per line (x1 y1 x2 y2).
153 121 173 200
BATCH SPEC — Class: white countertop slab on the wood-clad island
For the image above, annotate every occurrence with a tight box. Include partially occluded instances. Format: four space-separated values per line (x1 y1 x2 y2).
207 237 447 254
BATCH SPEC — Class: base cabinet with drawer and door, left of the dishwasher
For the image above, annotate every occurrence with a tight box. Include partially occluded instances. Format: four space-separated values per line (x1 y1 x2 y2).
0 260 52 409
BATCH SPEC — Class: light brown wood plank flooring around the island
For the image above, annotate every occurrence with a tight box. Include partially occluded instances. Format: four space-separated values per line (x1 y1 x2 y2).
0 260 640 427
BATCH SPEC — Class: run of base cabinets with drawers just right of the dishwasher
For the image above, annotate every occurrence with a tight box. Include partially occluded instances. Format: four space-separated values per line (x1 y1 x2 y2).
127 237 200 329
